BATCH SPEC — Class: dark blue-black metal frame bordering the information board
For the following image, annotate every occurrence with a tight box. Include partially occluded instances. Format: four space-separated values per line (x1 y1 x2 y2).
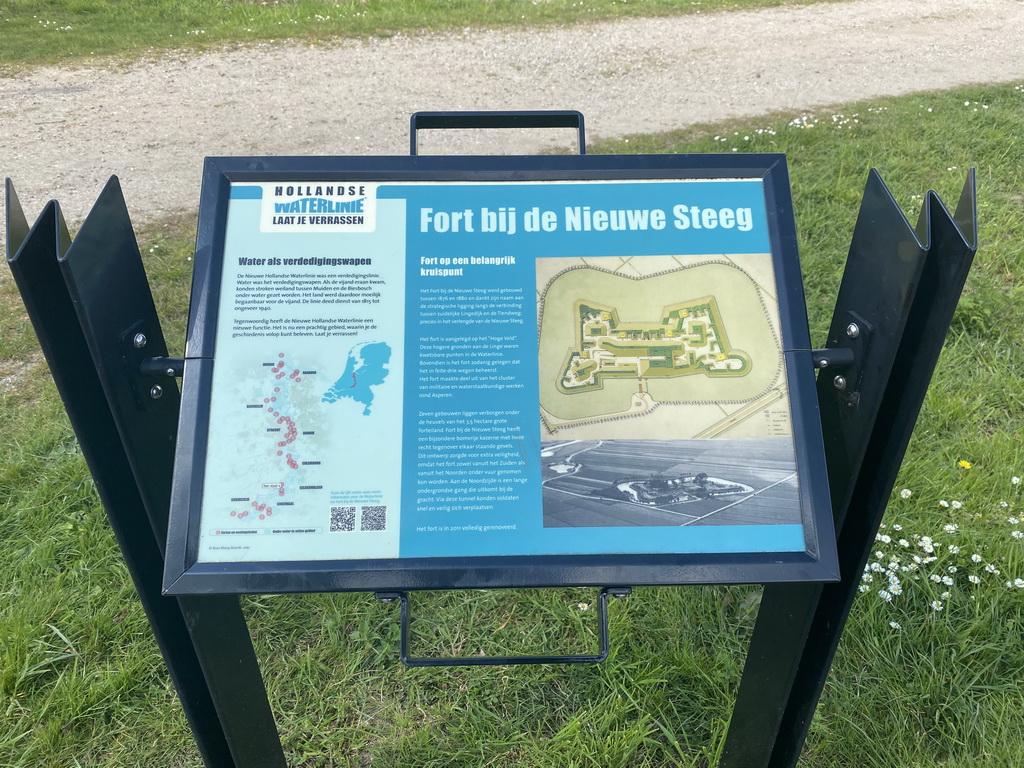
164 150 838 594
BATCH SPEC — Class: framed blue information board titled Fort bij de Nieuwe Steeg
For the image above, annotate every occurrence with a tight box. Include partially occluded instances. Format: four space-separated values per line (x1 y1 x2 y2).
165 156 837 593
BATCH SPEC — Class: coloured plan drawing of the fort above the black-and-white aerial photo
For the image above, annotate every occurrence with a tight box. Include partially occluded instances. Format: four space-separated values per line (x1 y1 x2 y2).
537 254 792 439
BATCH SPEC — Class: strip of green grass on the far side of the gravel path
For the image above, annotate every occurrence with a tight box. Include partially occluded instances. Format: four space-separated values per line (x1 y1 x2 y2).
0 0 835 75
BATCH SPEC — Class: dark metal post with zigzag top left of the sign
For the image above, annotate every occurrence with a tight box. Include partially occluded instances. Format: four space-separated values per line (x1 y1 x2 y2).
6 179 285 768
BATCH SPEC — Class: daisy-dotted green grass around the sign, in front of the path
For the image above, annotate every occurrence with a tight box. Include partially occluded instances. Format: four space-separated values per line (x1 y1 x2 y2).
0 85 1024 768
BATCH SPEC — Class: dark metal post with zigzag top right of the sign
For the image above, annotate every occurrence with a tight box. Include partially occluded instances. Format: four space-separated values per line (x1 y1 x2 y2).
720 171 977 768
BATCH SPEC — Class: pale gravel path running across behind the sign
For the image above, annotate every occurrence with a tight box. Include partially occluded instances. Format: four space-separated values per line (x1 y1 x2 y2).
0 0 1024 247
